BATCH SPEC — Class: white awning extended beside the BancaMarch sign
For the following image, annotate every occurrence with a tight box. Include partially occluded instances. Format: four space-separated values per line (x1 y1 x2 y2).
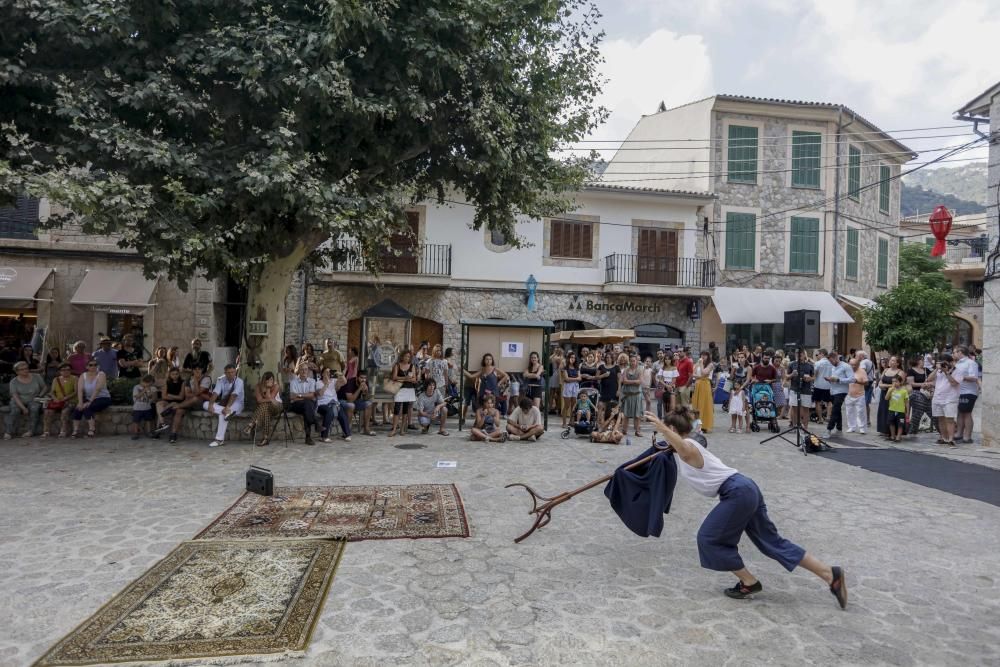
712 287 854 324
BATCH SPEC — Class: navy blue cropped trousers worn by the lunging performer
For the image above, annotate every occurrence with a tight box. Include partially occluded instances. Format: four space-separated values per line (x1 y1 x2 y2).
698 473 806 572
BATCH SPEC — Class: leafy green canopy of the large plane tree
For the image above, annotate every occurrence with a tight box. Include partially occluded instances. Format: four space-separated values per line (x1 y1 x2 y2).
0 0 605 285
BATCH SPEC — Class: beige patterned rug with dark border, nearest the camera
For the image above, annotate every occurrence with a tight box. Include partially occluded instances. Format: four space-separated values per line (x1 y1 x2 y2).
35 540 344 667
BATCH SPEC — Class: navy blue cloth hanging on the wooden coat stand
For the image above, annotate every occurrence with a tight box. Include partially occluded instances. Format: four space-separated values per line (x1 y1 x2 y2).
604 447 677 537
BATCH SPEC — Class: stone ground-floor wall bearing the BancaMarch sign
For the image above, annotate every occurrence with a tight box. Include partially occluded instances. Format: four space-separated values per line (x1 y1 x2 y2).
285 282 701 349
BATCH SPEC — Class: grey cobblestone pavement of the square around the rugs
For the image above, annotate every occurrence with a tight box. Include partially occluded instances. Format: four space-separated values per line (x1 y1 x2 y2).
0 420 1000 667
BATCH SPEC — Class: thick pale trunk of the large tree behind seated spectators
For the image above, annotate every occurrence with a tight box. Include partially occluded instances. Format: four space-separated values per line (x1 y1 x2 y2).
240 242 312 383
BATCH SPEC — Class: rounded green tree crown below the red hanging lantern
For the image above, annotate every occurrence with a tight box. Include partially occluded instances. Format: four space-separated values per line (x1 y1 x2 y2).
861 280 960 356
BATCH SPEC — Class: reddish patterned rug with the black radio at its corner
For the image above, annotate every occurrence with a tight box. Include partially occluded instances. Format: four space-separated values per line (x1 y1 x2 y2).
195 484 469 540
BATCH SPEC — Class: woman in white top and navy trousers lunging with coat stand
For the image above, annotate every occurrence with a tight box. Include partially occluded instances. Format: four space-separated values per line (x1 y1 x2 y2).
646 409 847 609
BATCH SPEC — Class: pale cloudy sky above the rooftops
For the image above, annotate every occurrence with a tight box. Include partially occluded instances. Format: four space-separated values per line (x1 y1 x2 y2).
590 0 1000 165
